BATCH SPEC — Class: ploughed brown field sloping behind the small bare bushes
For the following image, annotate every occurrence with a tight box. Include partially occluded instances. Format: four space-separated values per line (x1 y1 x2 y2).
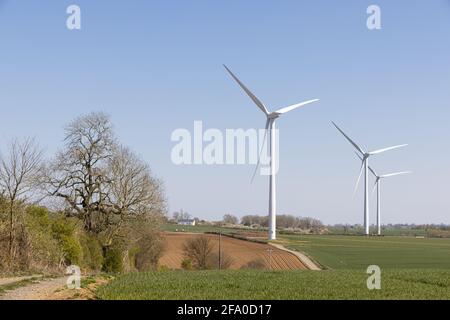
159 232 306 270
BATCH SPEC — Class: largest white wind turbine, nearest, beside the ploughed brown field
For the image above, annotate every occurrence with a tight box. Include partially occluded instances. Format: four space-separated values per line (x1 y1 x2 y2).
223 65 319 240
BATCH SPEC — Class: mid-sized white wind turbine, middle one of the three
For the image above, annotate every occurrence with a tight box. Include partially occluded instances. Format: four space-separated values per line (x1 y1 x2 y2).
332 121 407 235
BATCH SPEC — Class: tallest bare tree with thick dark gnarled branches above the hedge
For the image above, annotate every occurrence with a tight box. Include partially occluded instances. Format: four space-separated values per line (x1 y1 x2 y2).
45 113 114 232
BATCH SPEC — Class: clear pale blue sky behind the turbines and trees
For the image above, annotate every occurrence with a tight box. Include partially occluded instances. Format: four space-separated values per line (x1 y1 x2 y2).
0 0 450 223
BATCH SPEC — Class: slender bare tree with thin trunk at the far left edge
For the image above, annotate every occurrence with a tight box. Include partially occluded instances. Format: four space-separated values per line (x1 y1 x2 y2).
0 138 42 266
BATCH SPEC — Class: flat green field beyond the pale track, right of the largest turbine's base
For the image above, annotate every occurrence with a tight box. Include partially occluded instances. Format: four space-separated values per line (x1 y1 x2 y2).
277 235 450 270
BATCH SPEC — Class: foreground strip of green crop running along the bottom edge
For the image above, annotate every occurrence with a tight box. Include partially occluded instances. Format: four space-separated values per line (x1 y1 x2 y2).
96 269 450 300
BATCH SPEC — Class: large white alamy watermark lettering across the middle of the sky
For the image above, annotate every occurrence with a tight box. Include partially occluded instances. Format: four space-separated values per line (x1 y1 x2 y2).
170 121 279 175
